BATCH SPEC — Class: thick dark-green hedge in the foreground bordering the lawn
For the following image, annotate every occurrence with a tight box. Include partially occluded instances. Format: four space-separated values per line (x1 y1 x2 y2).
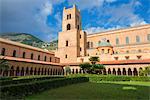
0 77 89 99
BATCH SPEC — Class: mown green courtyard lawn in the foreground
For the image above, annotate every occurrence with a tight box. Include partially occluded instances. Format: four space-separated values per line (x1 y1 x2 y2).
25 82 150 100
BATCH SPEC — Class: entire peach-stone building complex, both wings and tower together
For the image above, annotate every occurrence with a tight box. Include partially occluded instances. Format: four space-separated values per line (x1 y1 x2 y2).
0 5 150 76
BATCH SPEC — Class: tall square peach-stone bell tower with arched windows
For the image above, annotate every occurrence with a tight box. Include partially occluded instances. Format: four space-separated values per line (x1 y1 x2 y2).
56 5 81 63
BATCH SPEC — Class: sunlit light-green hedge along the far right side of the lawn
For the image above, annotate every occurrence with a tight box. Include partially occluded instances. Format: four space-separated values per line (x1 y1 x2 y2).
68 74 150 82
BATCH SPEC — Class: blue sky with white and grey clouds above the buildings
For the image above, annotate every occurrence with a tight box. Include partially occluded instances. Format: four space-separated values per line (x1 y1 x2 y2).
0 0 150 42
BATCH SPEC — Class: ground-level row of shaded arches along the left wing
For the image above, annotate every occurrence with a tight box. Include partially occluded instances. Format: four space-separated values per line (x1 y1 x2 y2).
0 66 63 76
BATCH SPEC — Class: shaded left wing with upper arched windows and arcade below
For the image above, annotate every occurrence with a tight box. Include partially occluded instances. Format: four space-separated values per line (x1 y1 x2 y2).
0 38 63 76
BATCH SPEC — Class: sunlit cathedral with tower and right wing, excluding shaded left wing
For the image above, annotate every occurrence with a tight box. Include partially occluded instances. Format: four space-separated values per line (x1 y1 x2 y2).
55 5 150 75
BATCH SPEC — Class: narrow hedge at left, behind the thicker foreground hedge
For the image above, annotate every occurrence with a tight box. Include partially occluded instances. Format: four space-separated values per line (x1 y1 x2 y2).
0 75 64 86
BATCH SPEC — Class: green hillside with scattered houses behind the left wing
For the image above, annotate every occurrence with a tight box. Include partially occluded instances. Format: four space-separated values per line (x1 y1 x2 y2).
0 33 57 50
